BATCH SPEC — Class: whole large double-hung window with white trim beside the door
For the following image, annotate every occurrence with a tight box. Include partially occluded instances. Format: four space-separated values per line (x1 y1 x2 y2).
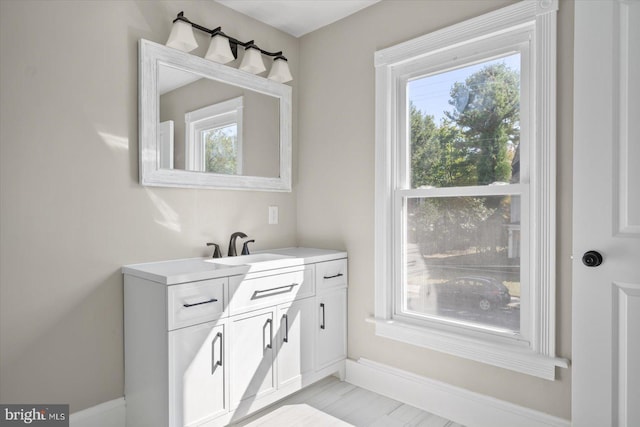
373 2 566 379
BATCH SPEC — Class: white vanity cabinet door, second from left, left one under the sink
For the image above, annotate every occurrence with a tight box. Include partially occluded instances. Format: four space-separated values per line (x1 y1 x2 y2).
229 310 275 408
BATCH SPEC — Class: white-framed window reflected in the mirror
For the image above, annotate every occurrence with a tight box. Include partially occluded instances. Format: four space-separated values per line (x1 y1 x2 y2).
185 97 242 175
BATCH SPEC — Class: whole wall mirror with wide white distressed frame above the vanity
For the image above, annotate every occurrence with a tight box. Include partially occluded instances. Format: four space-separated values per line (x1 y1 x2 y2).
138 39 291 191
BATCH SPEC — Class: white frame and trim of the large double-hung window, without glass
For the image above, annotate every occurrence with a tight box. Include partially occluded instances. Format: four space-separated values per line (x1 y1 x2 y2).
370 0 568 380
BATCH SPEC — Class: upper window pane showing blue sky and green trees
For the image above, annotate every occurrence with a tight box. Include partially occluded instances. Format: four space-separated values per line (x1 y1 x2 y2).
407 53 520 188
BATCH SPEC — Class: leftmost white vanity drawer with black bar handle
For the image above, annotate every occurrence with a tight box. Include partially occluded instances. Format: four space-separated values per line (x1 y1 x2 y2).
167 278 227 330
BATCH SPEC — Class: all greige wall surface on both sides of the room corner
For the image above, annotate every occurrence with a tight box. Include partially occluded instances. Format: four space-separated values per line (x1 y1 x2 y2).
0 0 573 418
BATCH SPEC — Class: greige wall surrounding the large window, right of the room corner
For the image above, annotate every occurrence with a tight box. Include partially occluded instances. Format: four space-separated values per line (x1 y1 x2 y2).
297 0 573 418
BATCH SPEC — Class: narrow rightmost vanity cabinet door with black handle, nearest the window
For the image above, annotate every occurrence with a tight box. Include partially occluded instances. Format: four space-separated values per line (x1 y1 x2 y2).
316 289 347 369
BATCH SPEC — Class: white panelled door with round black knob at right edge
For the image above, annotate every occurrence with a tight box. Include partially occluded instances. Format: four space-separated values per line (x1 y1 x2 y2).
572 0 640 427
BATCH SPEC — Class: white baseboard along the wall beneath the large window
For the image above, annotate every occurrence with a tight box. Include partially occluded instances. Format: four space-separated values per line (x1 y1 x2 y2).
346 359 571 427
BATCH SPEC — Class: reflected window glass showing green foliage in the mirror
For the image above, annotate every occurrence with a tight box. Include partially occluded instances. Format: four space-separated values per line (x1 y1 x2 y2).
201 123 238 175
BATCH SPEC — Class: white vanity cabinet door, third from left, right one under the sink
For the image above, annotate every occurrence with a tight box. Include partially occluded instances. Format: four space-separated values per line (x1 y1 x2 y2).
276 298 316 388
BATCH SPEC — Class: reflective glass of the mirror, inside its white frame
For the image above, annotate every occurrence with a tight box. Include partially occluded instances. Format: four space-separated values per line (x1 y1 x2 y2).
157 64 280 177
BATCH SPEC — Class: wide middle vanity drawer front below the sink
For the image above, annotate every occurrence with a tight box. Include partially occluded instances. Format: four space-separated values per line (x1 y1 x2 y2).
229 266 314 315
